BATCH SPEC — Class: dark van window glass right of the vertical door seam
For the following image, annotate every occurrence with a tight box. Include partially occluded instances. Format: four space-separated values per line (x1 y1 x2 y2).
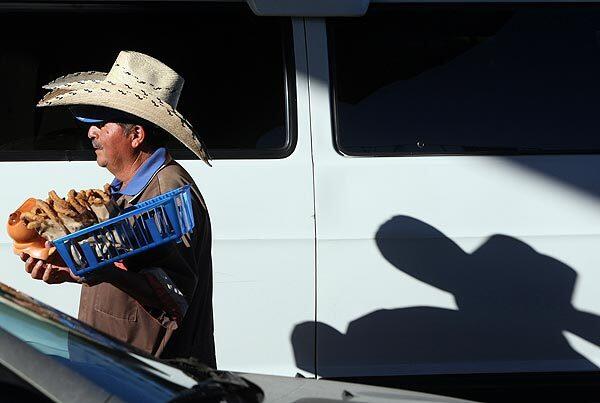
328 5 600 156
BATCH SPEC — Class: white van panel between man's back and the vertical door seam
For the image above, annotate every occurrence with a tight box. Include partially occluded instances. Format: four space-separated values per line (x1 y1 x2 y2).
205 20 315 376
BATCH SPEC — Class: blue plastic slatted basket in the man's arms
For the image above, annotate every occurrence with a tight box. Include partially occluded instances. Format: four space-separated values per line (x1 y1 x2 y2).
53 185 194 276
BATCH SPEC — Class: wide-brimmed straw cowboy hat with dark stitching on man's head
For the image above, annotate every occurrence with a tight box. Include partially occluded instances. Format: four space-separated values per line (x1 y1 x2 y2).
37 51 210 165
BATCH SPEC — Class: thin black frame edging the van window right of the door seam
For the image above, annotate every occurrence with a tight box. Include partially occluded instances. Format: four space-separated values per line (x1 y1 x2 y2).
325 2 600 158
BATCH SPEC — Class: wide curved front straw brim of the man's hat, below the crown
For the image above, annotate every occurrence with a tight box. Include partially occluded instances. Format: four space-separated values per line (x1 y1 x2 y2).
37 80 210 165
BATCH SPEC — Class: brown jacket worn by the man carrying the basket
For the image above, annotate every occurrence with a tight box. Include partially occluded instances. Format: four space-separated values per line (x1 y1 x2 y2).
79 156 216 367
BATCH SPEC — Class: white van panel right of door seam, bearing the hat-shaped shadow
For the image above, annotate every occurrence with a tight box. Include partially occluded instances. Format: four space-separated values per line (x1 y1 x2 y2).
296 19 600 377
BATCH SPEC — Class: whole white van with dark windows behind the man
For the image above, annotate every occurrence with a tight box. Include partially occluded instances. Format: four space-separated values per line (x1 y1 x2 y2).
0 0 600 398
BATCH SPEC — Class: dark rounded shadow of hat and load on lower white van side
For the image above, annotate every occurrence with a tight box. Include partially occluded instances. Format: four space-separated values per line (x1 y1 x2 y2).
291 216 600 377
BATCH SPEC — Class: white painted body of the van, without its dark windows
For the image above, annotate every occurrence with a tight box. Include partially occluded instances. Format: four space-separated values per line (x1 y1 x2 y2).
0 1 600 386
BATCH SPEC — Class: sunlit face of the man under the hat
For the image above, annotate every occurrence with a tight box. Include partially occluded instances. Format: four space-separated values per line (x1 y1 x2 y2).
88 122 134 175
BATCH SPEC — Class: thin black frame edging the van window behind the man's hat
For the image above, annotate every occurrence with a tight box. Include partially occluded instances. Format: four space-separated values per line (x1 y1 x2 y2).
0 1 298 162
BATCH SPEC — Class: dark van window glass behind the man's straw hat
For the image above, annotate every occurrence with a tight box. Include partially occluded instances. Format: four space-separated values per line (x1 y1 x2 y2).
0 3 295 161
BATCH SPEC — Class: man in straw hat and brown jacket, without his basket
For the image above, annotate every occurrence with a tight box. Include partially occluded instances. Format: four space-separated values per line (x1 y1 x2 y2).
21 52 216 367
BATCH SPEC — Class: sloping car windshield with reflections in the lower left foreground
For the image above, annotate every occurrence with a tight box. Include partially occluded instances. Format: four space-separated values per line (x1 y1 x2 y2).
0 283 197 402
